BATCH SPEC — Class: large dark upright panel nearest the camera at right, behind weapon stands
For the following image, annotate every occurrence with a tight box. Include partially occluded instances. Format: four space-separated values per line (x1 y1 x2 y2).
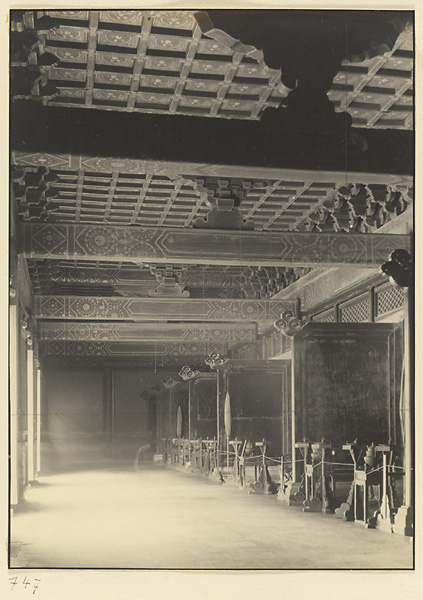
294 323 402 446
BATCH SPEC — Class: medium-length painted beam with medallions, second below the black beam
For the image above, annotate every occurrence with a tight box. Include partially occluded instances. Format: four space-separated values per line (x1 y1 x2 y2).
34 296 297 323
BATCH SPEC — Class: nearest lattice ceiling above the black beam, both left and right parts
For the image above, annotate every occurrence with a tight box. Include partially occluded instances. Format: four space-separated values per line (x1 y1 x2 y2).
24 10 414 129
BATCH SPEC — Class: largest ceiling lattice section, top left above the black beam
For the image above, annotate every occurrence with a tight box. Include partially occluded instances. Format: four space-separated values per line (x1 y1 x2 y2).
32 10 289 119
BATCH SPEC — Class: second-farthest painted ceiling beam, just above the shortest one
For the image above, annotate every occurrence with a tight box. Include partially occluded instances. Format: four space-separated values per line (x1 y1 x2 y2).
37 321 257 344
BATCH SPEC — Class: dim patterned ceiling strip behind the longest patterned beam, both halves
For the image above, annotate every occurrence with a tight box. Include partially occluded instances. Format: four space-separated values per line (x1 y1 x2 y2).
28 260 309 298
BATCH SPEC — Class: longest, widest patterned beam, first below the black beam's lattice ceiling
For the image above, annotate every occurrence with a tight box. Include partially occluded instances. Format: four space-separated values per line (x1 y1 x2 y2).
21 223 411 267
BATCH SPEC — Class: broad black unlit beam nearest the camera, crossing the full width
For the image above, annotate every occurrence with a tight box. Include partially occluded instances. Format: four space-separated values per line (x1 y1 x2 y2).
10 101 414 177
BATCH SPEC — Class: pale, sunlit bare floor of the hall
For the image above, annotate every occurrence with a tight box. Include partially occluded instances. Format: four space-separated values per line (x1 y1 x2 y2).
10 464 413 569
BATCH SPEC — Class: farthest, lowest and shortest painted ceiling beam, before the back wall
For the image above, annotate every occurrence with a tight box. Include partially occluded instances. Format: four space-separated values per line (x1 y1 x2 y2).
40 340 228 357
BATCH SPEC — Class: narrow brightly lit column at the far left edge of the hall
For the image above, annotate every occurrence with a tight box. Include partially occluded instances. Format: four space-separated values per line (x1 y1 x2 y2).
9 300 20 506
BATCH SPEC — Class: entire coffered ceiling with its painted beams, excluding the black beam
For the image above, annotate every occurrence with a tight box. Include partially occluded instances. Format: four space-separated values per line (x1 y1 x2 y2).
11 9 414 369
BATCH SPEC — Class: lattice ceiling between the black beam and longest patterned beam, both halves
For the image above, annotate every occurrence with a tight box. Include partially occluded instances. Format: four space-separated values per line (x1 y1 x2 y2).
12 167 412 237
